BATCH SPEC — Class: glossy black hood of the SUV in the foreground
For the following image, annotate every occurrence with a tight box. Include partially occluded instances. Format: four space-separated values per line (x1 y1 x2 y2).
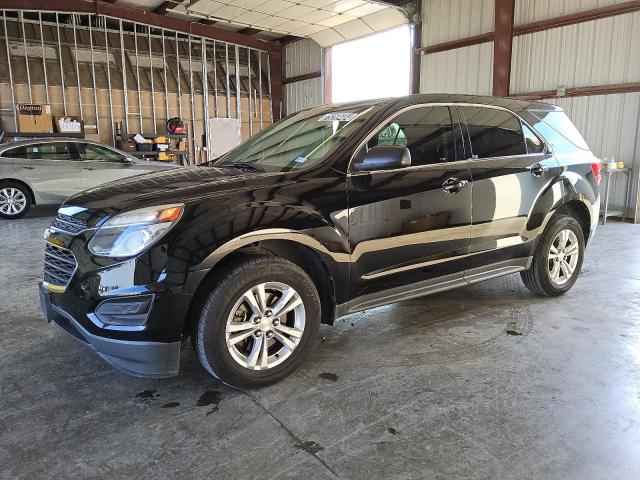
63 166 282 215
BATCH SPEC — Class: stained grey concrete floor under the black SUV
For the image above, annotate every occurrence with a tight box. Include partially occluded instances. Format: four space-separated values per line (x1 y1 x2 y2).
0 208 640 480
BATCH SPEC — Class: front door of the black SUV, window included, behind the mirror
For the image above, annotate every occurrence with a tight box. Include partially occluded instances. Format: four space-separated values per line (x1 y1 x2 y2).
347 106 471 311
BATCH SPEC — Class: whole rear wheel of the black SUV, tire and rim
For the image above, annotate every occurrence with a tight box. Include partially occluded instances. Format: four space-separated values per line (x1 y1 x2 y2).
520 215 585 296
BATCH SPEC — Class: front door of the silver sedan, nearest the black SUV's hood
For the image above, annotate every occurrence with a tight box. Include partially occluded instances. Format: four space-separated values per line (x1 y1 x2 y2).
74 142 145 190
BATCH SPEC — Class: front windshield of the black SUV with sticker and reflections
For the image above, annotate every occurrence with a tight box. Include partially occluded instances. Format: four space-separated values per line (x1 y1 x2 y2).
213 106 377 172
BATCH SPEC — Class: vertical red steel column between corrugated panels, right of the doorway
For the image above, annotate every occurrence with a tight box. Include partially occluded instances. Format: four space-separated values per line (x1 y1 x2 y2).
493 0 516 97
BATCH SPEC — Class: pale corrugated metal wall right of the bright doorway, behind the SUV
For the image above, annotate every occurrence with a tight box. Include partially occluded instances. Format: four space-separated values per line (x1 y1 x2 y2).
420 0 640 215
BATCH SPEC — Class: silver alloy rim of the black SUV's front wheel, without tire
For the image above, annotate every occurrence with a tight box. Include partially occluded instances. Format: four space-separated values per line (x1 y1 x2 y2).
225 282 305 370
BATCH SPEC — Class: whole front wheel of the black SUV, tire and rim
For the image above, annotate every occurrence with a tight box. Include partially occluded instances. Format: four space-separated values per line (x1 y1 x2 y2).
195 256 321 388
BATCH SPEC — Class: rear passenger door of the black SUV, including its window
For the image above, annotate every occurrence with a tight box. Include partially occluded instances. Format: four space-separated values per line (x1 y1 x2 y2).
458 106 561 279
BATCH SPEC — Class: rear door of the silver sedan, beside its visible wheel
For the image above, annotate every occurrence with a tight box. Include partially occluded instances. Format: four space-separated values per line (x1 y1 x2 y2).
2 142 81 203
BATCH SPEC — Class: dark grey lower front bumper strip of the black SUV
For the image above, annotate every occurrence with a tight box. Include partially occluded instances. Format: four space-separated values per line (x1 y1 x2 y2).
40 283 181 378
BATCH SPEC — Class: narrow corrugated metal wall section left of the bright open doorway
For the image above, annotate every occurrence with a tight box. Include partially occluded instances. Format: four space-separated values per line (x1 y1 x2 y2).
283 39 324 115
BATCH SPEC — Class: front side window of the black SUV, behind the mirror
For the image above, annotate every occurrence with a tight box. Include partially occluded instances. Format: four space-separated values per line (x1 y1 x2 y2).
369 107 456 165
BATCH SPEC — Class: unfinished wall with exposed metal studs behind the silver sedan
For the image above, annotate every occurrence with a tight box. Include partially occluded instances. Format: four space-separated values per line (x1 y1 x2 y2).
0 10 272 165
